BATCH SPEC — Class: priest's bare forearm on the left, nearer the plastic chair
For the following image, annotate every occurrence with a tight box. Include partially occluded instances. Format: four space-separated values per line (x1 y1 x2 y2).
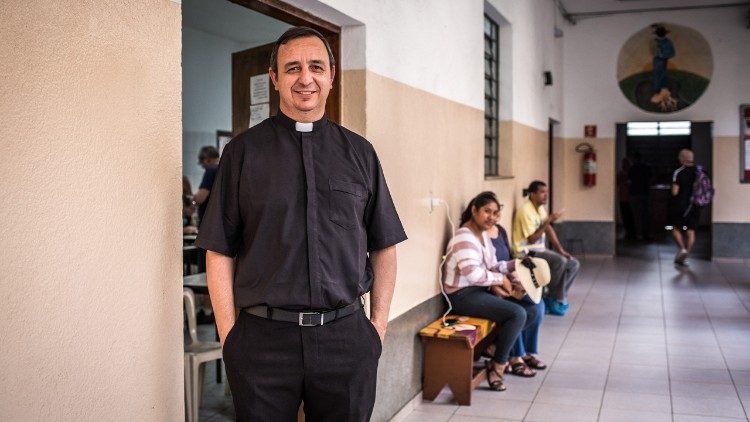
206 251 235 345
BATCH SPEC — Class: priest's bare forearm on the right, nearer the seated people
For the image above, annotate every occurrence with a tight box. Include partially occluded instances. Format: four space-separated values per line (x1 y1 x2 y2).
370 246 396 340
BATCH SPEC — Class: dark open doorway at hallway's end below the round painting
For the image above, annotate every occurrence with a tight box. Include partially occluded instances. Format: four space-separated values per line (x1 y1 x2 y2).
615 121 713 259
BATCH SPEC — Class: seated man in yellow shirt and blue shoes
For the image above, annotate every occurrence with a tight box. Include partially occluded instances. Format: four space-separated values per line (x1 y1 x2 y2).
513 180 581 316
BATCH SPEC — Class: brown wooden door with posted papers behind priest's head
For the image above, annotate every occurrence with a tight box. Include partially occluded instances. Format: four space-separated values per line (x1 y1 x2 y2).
232 34 341 136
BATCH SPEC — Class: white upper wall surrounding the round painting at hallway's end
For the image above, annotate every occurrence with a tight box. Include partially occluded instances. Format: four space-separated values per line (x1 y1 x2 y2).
562 8 750 138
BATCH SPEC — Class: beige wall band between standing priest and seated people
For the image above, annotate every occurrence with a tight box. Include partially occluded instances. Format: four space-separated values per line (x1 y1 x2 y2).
362 71 547 319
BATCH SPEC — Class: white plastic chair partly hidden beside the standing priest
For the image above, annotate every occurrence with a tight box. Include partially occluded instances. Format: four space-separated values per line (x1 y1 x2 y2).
182 288 222 422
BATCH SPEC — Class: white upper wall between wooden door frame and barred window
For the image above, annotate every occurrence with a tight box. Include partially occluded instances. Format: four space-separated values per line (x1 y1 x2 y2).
308 0 484 109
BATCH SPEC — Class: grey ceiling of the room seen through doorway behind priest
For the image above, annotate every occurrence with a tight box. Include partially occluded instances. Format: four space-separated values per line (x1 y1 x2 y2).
182 0 291 47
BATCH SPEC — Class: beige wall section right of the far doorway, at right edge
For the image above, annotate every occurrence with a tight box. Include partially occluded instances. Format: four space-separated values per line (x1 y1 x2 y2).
712 136 750 223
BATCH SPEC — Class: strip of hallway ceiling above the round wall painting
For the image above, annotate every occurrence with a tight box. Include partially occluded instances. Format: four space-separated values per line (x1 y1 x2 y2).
555 0 750 20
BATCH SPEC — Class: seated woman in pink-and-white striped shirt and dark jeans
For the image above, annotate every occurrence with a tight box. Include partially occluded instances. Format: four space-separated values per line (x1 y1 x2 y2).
442 192 534 391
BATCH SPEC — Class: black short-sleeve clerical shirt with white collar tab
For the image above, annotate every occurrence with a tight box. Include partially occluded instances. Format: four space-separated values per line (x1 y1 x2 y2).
196 112 406 310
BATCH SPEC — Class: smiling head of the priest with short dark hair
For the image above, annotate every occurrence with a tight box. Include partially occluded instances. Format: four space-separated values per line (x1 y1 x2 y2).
268 36 335 123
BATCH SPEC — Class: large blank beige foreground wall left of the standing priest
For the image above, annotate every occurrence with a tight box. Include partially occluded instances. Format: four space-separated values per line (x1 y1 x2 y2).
0 0 183 421
